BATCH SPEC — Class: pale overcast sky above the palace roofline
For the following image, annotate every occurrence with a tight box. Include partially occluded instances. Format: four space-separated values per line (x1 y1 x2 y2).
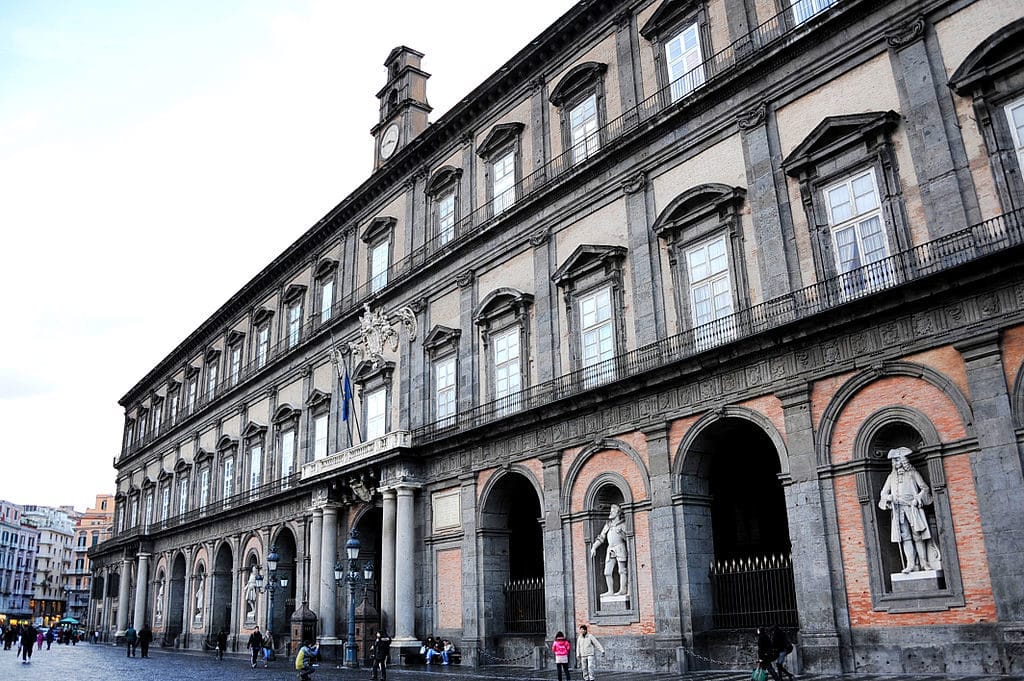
0 0 573 510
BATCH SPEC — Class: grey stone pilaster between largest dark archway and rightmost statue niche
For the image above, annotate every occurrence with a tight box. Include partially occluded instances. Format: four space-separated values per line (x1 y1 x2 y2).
778 386 850 673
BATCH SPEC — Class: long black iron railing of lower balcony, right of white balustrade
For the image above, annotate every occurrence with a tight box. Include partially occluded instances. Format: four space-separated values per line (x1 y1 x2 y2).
413 209 1024 446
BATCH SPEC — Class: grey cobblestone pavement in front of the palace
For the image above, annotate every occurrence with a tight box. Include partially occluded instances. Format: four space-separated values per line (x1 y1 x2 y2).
0 643 1024 681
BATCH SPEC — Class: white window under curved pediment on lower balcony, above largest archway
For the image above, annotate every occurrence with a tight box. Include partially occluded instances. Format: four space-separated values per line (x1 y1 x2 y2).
686 236 735 347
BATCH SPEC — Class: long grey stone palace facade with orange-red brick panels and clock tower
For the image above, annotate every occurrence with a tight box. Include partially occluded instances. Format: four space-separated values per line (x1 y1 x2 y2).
90 0 1024 673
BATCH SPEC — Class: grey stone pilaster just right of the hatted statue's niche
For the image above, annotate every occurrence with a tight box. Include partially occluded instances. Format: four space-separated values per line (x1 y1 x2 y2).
956 332 1024 623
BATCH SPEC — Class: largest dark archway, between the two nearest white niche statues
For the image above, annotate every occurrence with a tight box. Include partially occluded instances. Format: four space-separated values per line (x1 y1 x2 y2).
680 415 798 636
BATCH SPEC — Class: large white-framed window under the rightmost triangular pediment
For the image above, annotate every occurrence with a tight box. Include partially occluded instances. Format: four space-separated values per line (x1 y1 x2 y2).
824 170 893 297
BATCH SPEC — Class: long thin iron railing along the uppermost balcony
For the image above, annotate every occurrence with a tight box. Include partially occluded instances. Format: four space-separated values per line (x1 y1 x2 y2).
119 0 847 453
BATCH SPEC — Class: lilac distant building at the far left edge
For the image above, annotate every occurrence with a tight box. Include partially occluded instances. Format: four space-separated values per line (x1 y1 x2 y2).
0 501 39 626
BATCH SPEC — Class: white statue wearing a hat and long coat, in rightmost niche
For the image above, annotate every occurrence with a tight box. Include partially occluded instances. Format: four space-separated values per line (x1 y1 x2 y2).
879 446 941 574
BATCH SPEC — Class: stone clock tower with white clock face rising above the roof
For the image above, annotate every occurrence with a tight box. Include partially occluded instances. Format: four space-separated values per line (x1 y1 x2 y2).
370 45 431 170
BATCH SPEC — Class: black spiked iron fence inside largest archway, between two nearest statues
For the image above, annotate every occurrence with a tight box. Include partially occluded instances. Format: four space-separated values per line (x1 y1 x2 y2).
710 555 799 629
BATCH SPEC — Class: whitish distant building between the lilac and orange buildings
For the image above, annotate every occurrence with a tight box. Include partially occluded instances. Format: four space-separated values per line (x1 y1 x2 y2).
23 505 77 627
